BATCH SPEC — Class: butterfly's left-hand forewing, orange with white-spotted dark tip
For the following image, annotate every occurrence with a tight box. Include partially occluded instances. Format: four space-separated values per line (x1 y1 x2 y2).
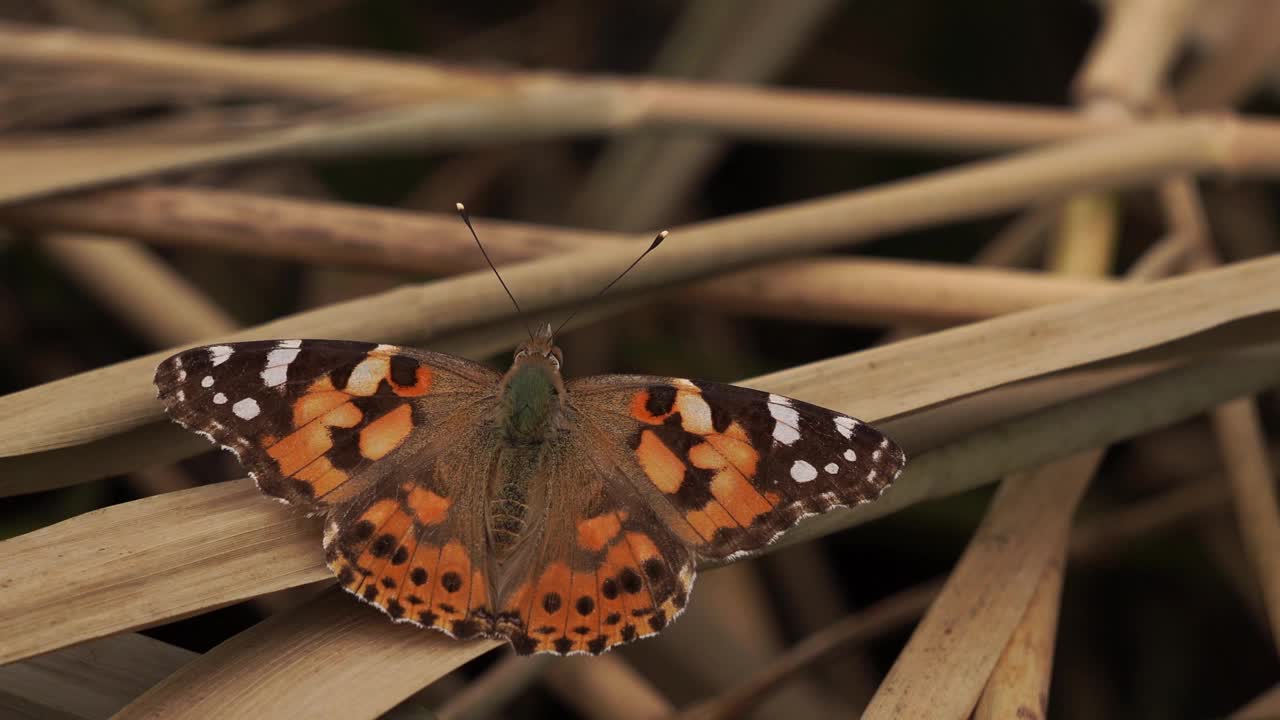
155 340 498 512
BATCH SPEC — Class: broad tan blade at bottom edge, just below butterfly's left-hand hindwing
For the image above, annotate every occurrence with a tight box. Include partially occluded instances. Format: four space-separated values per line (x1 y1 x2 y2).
116 588 499 720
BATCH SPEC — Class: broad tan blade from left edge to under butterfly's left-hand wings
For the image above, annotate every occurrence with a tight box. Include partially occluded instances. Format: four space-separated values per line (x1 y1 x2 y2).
0 480 332 664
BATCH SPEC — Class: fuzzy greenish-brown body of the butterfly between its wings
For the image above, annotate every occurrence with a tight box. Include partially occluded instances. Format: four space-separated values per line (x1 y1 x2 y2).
488 342 564 559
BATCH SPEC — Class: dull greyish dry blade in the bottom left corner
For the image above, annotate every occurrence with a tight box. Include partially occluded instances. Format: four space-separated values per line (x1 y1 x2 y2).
0 633 196 720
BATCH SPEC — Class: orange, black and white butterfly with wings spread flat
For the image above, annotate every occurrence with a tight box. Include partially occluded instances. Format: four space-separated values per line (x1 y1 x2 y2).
155 208 905 655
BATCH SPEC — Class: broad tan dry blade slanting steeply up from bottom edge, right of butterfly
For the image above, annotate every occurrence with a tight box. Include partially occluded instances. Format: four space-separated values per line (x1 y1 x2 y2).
865 451 1102 717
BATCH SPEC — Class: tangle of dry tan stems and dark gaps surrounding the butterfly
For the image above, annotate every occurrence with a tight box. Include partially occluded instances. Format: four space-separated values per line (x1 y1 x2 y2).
0 0 1280 720
